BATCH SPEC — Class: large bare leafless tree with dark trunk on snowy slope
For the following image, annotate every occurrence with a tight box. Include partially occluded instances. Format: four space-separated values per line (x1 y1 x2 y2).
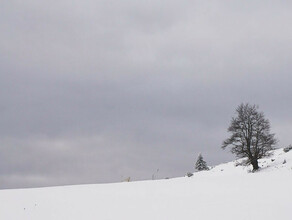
222 103 277 170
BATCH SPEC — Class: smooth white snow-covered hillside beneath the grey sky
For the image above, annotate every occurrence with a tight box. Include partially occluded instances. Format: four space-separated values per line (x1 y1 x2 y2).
0 149 292 220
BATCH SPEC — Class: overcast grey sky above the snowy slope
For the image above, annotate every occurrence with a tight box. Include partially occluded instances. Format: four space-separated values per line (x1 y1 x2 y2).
0 0 292 189
